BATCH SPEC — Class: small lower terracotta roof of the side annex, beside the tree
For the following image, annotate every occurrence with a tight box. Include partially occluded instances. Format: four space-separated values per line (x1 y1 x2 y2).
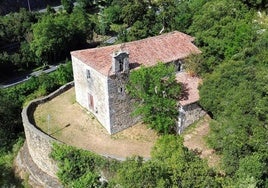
176 72 202 106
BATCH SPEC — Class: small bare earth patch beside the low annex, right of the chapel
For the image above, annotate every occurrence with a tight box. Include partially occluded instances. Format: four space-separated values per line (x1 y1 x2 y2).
183 116 220 167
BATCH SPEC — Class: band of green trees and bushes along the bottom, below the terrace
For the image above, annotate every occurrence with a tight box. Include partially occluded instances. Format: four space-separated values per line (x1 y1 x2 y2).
51 135 220 188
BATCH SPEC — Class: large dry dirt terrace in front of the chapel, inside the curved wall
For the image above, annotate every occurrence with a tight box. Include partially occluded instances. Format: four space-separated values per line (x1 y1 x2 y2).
34 88 158 159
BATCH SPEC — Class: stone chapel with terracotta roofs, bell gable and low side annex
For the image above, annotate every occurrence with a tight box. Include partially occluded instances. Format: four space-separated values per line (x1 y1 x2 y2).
71 31 204 134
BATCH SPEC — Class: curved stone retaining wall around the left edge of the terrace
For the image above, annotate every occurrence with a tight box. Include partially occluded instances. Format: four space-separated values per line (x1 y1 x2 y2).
20 82 74 187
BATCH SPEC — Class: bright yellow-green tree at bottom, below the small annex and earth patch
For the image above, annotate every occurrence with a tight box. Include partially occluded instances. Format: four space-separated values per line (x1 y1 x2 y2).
151 135 220 187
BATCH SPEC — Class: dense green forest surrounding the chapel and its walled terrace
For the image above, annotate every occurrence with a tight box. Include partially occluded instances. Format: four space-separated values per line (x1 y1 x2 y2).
0 0 268 187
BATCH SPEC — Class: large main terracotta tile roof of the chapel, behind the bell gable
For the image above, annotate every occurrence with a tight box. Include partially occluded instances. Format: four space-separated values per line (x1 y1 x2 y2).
71 31 201 76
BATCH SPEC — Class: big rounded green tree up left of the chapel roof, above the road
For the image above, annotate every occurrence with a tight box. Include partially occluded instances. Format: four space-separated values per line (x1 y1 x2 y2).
30 9 92 63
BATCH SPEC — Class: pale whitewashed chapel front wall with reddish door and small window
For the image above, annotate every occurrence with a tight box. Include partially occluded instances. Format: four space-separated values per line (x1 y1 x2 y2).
72 57 111 133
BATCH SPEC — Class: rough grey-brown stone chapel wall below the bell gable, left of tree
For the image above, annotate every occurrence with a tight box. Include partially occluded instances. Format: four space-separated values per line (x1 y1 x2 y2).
108 73 140 134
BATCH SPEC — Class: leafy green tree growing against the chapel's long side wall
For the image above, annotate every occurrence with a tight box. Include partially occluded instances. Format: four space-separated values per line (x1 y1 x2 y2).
127 63 181 133
